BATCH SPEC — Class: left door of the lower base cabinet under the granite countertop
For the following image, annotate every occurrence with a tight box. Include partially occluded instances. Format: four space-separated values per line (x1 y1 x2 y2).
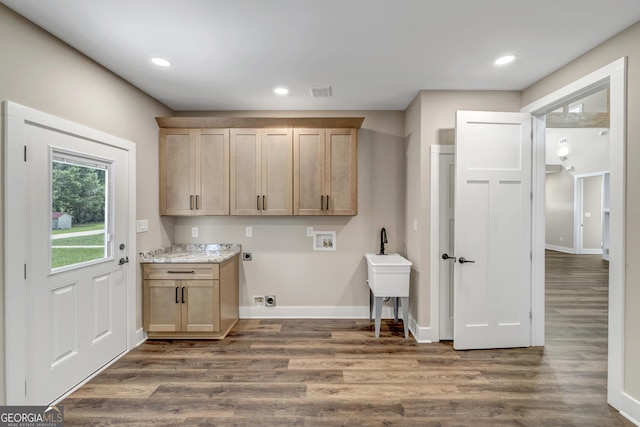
143 280 182 332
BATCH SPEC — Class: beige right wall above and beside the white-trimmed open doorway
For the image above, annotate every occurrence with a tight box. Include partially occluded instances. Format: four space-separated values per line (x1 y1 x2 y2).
522 19 640 400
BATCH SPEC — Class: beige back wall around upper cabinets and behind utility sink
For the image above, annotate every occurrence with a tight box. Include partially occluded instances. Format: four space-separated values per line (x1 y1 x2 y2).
168 111 405 315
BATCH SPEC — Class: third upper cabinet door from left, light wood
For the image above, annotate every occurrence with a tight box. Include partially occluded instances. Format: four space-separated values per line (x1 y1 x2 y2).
229 129 262 215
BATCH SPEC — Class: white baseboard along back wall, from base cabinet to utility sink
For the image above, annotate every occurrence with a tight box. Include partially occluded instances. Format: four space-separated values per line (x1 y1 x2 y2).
240 303 402 319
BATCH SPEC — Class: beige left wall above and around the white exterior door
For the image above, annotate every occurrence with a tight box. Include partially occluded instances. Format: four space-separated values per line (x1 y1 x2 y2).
0 5 173 402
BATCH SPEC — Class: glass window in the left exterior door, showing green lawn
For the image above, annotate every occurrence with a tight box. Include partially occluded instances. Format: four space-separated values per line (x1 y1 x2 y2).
50 152 111 271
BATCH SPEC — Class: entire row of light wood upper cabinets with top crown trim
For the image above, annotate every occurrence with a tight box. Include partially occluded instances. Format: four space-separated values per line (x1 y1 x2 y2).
156 117 364 215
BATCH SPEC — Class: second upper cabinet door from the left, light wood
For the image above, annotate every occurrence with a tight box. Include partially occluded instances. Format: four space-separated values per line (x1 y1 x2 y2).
200 129 229 215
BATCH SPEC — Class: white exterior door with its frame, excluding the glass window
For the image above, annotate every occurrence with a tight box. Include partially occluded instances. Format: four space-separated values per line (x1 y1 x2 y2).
4 102 139 405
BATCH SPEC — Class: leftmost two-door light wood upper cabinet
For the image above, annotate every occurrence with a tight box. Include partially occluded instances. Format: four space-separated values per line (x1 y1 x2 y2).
160 129 229 215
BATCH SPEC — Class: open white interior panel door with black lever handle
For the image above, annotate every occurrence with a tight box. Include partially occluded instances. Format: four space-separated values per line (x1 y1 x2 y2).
454 111 532 350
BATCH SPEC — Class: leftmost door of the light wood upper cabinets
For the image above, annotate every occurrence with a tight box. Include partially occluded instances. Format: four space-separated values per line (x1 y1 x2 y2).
159 129 196 215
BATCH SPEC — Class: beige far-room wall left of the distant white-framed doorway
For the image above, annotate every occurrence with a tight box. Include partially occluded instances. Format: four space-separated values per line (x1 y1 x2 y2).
544 168 574 252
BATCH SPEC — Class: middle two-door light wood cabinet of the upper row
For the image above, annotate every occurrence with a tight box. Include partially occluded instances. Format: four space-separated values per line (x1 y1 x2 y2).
230 129 293 215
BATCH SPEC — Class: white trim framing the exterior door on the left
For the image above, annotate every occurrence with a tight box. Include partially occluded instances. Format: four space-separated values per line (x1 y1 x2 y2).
3 101 142 405
